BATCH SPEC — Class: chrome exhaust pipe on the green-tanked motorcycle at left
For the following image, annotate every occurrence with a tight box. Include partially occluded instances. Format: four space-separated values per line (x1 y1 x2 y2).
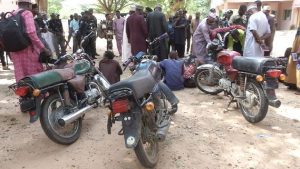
58 105 94 126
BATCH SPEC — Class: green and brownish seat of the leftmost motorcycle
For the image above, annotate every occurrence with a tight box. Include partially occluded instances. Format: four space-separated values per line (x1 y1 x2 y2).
23 68 75 89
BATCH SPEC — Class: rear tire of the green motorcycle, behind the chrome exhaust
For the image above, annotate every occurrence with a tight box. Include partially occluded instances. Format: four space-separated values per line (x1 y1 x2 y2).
40 94 82 145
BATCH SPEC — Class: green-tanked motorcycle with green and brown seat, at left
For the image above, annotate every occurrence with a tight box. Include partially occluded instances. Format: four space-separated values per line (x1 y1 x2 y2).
9 33 110 145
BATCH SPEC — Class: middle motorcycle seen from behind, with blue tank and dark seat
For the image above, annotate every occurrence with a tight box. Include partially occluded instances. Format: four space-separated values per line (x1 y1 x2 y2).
107 33 172 168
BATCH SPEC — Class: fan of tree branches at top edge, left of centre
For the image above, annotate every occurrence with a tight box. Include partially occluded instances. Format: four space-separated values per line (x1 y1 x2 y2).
96 0 130 13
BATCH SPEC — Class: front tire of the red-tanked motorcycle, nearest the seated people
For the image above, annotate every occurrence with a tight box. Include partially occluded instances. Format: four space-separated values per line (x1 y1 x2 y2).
195 69 223 95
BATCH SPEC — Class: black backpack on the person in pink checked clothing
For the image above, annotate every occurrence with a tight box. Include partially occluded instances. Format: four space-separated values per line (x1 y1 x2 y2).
0 10 31 52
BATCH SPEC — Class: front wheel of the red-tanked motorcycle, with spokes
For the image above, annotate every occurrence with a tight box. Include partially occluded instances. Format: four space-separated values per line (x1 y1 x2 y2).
195 69 223 95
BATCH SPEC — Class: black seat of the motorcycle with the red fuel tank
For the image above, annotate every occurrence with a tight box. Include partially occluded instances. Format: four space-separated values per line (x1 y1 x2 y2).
232 57 276 74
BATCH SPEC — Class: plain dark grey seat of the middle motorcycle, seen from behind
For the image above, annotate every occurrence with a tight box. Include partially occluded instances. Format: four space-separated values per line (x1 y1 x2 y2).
108 69 157 98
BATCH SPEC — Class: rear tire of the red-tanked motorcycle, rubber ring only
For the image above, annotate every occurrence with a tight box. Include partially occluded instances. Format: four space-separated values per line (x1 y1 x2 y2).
239 80 269 123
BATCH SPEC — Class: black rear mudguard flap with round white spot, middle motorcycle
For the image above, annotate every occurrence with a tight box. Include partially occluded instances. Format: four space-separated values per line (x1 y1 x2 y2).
122 113 142 148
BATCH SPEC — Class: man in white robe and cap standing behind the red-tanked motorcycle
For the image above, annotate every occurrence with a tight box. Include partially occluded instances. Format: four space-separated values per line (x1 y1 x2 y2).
243 4 271 57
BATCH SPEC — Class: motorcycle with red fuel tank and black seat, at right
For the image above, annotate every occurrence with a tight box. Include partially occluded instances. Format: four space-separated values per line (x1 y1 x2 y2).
195 32 285 123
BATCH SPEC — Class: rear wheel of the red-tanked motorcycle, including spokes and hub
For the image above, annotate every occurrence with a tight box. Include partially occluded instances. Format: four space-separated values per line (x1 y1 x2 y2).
239 80 269 123
